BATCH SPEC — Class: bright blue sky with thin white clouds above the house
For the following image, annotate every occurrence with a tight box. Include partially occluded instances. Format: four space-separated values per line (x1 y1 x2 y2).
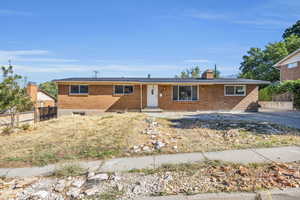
0 0 300 82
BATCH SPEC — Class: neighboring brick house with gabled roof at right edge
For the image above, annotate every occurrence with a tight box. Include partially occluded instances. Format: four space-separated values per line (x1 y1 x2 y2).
274 49 300 81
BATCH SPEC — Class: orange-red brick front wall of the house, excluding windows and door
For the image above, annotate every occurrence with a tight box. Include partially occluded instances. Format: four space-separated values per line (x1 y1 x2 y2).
57 85 258 111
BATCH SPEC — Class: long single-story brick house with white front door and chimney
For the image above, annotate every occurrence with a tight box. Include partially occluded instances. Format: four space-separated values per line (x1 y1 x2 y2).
53 70 269 115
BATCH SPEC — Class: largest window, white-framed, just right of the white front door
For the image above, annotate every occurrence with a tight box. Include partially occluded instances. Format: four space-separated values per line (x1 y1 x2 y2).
173 86 198 101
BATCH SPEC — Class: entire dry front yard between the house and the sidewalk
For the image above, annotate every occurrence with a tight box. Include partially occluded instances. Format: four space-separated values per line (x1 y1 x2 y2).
0 113 300 167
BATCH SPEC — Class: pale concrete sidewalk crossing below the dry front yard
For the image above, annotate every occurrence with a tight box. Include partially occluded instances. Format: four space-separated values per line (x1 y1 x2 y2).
0 146 300 177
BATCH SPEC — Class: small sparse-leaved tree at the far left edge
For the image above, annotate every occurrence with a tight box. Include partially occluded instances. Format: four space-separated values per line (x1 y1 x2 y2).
0 66 33 127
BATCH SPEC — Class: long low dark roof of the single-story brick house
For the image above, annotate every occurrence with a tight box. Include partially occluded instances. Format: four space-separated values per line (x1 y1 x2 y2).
53 77 270 84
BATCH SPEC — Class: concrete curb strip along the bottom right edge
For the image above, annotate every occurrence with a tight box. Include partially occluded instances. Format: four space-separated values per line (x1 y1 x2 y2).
138 188 300 200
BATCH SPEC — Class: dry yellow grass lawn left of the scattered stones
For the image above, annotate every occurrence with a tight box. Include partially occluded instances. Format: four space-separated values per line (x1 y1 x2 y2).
0 113 146 167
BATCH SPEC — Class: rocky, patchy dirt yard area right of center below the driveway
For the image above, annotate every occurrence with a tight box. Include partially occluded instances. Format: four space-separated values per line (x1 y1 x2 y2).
157 119 300 152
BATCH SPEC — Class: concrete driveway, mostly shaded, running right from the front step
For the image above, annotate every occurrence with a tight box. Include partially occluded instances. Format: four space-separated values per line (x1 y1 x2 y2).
148 110 300 129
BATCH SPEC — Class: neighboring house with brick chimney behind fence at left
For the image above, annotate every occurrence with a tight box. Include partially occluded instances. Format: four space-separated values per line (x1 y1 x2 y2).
27 82 56 107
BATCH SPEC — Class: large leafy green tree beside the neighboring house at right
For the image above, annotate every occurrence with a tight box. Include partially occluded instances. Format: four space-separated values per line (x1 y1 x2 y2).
239 35 300 82
